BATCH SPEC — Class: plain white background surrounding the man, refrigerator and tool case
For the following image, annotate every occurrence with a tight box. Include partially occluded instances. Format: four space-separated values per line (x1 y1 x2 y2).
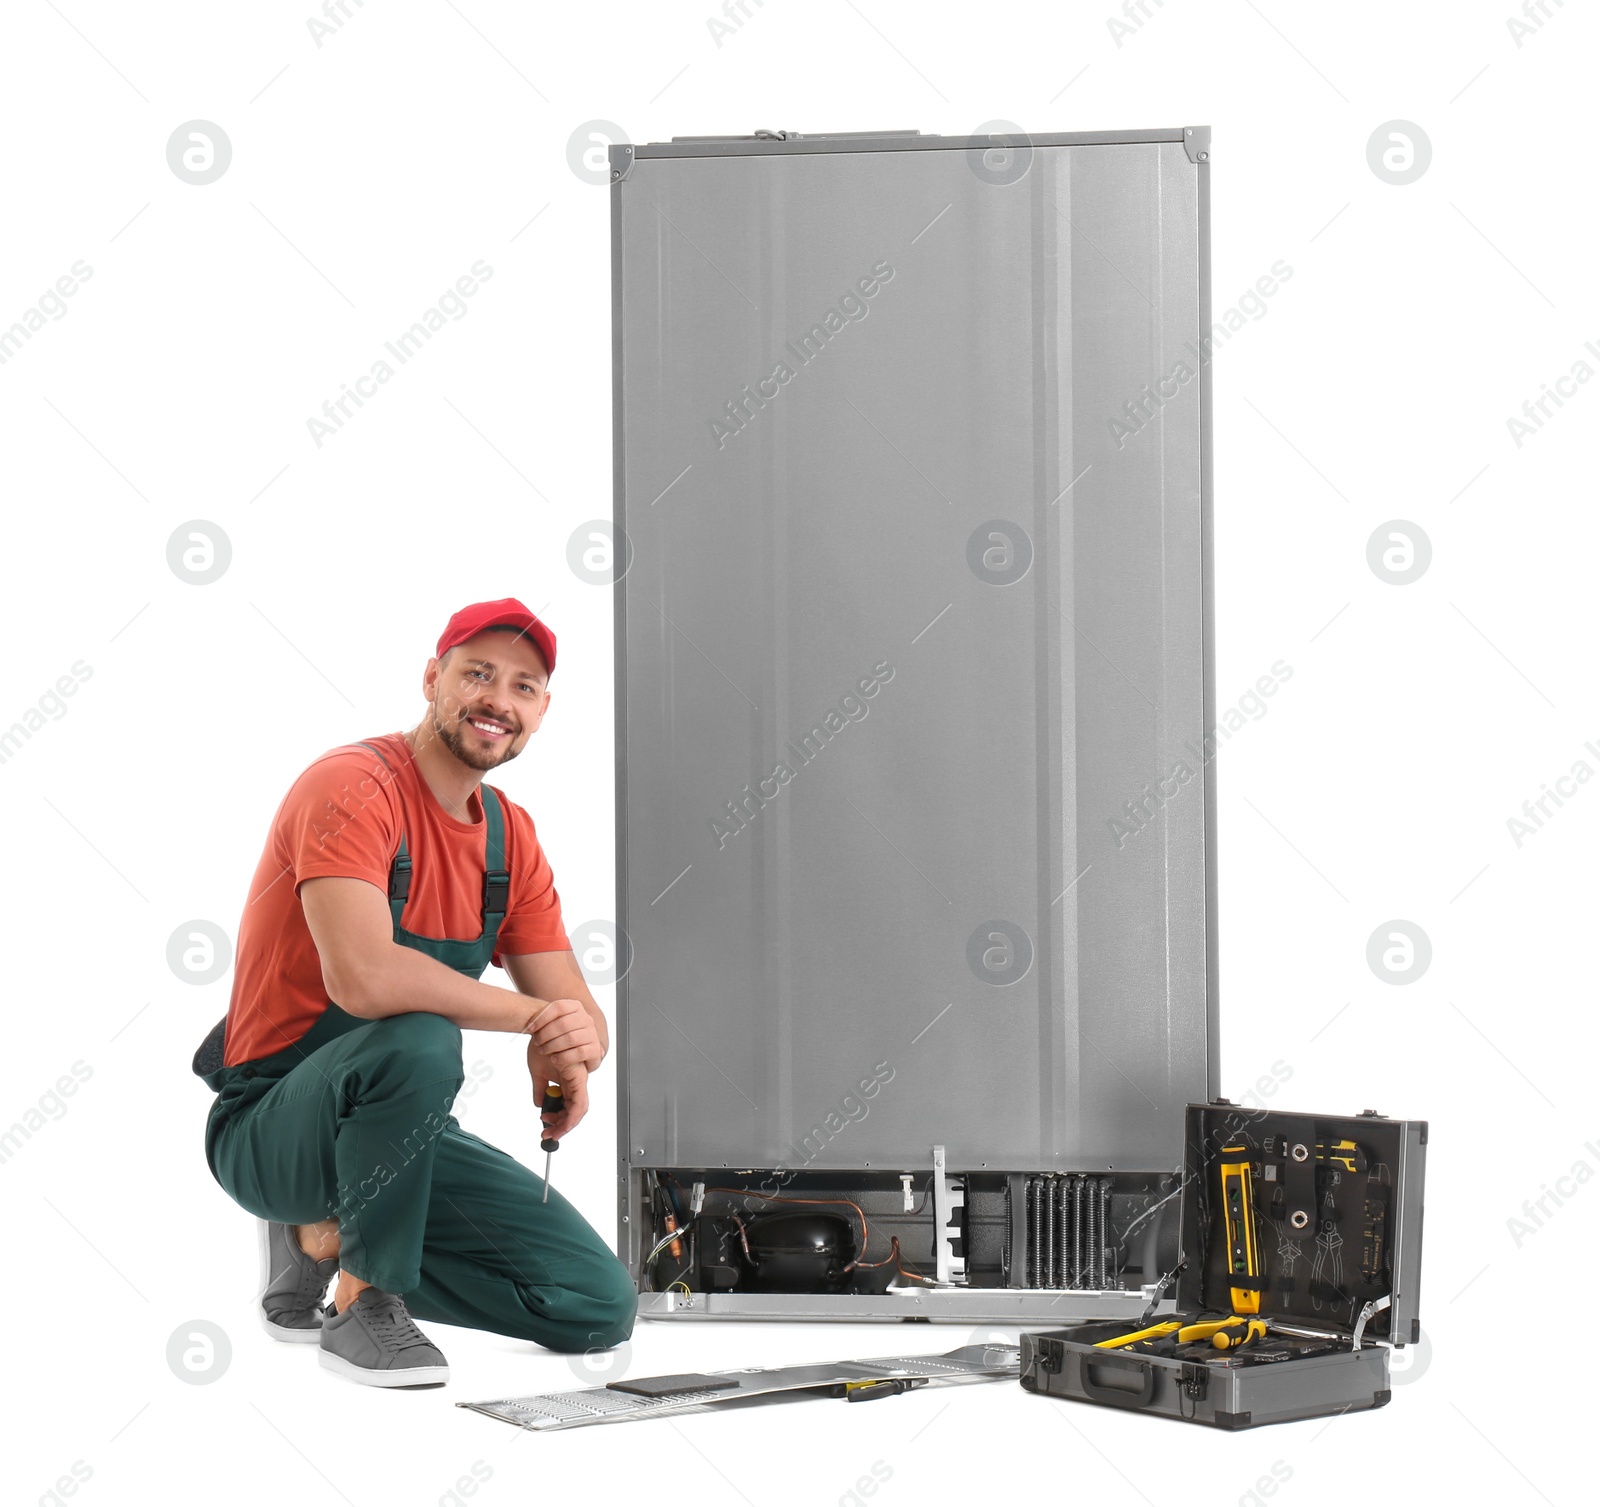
0 0 1600 1507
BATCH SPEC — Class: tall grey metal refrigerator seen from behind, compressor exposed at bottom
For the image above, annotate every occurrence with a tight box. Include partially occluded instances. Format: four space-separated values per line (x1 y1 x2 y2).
611 126 1218 1323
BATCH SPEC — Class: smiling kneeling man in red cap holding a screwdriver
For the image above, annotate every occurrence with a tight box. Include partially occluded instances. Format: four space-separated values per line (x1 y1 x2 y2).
195 598 635 1387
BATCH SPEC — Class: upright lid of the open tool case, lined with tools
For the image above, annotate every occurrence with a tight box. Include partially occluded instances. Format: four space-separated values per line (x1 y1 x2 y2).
1176 1099 1427 1345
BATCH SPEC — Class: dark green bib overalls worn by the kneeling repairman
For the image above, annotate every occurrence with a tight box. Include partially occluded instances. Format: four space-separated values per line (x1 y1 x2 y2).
203 744 637 1352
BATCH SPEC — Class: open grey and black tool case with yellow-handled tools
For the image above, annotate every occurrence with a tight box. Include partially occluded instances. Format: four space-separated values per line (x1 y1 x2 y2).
1019 1101 1427 1429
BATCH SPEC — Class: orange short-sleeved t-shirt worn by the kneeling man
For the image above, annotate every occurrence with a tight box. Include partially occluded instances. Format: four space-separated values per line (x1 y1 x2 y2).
222 733 571 1067
